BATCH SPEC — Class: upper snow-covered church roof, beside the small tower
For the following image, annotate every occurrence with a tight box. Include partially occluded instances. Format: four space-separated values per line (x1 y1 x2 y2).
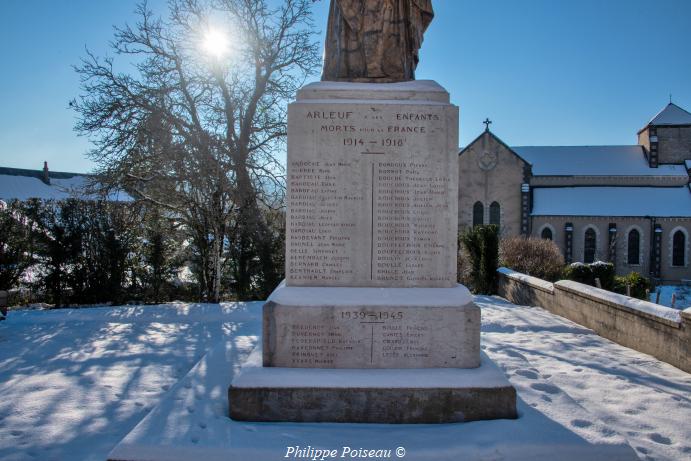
511 145 688 177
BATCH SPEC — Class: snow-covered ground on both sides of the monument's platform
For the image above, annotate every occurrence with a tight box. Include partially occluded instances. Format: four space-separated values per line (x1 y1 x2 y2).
0 297 691 461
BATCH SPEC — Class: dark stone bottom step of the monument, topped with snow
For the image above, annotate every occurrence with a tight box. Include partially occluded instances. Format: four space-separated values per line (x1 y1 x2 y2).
228 348 517 424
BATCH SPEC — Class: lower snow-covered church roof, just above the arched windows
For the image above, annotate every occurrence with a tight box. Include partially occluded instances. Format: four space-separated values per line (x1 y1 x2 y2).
532 186 691 217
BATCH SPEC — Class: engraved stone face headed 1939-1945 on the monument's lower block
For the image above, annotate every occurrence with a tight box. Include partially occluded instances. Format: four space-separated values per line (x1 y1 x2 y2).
264 306 479 368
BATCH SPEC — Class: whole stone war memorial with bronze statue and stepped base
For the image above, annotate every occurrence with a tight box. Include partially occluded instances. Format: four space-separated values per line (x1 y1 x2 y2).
228 0 516 423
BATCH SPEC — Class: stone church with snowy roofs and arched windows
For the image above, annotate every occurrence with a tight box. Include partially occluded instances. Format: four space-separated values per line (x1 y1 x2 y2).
459 103 691 283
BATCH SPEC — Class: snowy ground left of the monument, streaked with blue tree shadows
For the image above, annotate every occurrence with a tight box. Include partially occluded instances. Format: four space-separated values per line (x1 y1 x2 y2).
0 303 261 461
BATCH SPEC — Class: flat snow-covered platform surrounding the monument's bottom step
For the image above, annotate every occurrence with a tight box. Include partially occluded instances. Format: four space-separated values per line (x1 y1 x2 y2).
109 324 638 461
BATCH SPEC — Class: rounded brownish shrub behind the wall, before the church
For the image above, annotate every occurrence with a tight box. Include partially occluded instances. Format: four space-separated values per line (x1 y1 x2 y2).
499 237 564 282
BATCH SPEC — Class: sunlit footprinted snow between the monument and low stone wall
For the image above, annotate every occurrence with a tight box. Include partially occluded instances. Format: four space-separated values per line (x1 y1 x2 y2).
476 297 691 460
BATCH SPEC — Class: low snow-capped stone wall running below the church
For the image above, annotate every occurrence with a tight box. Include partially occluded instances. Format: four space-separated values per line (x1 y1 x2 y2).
498 268 691 373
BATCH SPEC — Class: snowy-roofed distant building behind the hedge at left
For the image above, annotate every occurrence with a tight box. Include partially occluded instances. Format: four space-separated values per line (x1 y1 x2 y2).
0 162 132 202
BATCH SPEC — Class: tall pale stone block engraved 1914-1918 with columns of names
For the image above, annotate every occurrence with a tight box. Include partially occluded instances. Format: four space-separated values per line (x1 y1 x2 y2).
286 81 458 287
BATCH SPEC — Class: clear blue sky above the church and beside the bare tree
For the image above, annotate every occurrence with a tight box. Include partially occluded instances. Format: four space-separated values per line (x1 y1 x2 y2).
0 0 691 172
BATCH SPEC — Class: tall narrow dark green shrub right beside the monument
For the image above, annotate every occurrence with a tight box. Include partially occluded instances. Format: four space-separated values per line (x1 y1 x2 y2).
460 224 499 295
